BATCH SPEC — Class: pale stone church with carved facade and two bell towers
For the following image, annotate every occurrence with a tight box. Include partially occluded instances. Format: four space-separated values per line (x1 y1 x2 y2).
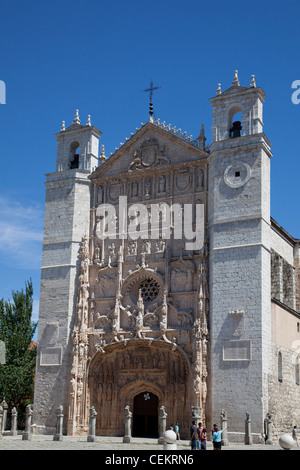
33 72 300 441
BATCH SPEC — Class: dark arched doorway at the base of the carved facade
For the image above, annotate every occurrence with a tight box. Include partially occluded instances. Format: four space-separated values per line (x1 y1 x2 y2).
132 391 158 437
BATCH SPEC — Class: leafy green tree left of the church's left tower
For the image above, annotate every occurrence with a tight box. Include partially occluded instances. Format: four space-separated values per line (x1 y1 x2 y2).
0 280 37 411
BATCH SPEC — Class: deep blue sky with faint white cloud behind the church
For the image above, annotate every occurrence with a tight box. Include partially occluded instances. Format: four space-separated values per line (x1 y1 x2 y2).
0 0 300 334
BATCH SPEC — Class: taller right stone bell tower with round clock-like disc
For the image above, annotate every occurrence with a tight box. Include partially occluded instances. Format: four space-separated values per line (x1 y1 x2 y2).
208 71 271 432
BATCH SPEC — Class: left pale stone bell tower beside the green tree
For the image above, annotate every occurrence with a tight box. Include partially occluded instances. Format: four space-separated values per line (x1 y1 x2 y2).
34 110 101 432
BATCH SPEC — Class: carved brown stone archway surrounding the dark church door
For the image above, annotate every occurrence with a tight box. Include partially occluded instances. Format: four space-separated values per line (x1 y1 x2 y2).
88 339 190 436
